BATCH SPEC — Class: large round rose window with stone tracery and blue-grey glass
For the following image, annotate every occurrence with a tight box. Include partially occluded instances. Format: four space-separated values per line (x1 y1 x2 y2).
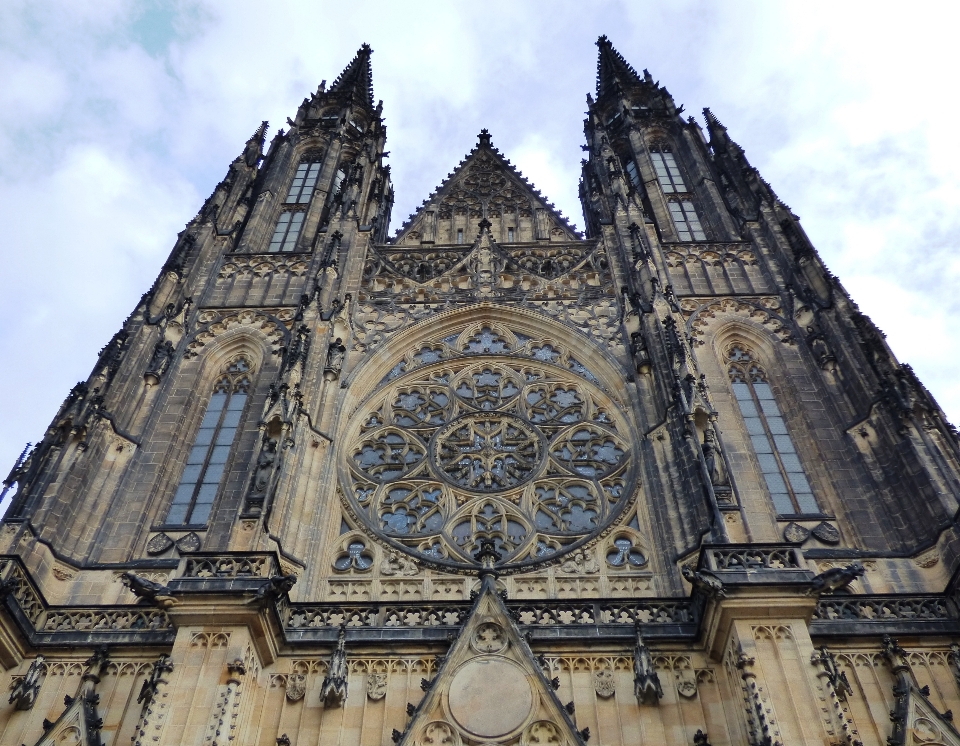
341 356 634 569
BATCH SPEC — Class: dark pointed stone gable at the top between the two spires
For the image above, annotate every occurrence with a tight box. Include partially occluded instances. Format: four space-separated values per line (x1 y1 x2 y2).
392 130 580 245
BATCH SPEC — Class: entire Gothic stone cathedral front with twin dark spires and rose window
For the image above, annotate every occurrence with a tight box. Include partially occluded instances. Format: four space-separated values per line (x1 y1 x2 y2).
0 37 960 746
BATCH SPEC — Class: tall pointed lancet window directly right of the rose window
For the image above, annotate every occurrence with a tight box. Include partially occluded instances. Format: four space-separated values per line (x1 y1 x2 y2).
727 345 820 515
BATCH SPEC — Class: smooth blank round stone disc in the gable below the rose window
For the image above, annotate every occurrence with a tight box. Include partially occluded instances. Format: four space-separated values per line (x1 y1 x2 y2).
449 658 533 738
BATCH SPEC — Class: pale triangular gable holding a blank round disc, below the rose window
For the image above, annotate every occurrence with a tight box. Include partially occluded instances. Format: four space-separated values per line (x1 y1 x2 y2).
398 575 585 746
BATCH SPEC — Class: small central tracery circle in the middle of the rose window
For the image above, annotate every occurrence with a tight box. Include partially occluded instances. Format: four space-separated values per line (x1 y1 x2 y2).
433 412 543 492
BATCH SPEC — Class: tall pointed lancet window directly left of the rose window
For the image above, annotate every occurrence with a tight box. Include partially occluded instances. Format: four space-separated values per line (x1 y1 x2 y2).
166 357 250 526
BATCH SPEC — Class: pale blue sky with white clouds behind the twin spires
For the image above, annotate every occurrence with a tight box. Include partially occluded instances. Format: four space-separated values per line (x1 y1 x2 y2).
0 0 960 500
